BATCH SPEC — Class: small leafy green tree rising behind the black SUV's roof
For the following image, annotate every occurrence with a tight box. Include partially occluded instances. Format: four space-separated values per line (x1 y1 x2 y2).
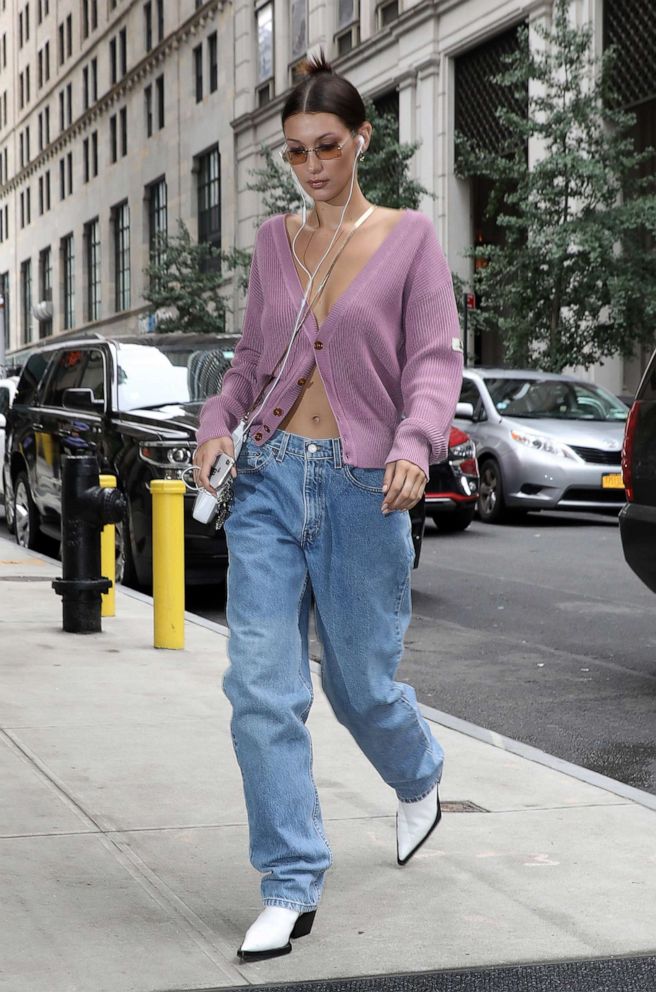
144 220 249 334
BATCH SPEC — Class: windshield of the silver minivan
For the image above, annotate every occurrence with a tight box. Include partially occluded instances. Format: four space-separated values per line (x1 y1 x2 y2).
485 377 628 421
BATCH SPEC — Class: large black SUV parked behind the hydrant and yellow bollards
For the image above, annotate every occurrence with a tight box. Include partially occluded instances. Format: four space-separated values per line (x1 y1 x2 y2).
3 334 469 585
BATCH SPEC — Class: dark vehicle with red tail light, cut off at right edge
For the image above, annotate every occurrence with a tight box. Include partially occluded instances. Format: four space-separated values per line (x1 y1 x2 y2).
620 351 656 592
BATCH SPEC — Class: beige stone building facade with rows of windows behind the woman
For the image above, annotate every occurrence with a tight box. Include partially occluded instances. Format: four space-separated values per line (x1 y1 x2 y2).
0 0 656 392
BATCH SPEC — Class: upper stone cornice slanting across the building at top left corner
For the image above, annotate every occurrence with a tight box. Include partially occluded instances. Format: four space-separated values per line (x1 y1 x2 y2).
0 0 232 199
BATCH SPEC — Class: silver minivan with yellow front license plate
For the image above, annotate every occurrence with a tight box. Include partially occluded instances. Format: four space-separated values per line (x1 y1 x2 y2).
457 368 628 523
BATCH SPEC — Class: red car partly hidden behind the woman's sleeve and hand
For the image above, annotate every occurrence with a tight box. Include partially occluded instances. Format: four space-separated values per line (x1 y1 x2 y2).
424 426 479 533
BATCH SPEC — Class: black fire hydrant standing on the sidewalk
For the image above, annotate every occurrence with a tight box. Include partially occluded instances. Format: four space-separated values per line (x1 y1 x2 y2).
52 455 126 634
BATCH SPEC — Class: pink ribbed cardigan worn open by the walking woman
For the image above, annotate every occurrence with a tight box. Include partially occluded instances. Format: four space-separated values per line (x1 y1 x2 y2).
197 210 462 475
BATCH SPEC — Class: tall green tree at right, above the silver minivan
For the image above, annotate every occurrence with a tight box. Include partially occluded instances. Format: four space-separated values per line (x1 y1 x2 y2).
456 0 656 371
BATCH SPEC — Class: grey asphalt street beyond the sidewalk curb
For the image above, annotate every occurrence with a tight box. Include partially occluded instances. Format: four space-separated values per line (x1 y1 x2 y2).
0 513 656 793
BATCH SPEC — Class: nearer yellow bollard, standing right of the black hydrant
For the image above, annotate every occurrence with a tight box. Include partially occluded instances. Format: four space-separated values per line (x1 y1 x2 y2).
150 479 186 648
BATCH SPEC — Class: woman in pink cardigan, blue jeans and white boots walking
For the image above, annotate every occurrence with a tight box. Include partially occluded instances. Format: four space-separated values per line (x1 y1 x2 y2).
194 53 462 959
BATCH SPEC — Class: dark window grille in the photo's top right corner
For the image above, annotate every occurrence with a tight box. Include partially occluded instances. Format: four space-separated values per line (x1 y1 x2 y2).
603 0 656 107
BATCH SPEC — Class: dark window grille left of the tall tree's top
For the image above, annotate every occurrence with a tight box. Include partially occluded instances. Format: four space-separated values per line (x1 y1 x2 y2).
455 27 528 170
